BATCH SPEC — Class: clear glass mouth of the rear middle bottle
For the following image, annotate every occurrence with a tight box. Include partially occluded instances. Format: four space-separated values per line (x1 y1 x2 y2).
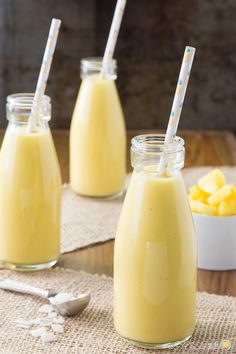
80 57 117 80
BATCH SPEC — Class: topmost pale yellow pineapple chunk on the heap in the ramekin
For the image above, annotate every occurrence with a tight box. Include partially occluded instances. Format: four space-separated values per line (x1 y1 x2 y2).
198 169 225 194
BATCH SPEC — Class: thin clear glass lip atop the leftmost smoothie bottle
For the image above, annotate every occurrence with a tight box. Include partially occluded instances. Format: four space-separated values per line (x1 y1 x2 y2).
7 93 51 108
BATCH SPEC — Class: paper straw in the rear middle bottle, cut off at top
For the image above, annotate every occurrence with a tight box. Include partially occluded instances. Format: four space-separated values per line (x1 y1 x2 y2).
101 0 126 75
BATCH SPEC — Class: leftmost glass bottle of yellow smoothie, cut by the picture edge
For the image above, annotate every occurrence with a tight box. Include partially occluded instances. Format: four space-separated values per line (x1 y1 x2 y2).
0 93 61 270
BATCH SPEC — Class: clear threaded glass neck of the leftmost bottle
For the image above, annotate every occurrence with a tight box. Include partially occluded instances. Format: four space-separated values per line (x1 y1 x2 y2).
6 93 51 128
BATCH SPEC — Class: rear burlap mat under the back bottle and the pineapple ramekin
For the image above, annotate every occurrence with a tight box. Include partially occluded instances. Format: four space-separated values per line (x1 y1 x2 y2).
61 167 236 253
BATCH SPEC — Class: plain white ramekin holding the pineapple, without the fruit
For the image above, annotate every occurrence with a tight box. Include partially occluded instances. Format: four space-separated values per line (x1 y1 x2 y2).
193 213 236 270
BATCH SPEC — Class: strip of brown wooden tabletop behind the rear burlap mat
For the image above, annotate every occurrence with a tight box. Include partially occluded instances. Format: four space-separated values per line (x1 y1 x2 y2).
50 130 236 183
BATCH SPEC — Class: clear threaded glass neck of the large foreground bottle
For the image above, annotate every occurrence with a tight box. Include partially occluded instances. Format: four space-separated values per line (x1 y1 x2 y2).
131 134 185 176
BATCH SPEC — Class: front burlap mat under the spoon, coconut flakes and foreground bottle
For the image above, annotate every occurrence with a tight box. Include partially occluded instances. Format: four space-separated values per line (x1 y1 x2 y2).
0 268 236 354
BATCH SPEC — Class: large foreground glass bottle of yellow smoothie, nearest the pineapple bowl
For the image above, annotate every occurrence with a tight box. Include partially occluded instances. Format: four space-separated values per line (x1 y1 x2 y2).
114 135 196 348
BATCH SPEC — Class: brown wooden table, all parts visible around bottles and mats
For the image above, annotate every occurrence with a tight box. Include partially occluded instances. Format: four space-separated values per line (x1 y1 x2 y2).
0 130 236 296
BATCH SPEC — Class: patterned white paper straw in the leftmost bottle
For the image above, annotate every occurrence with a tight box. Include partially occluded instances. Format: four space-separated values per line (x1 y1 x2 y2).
29 18 61 132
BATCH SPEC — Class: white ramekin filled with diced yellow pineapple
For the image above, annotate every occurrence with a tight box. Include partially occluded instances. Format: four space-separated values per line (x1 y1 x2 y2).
189 169 236 270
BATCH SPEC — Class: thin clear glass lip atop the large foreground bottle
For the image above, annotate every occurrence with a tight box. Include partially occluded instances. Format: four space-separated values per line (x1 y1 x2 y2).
131 134 184 154
